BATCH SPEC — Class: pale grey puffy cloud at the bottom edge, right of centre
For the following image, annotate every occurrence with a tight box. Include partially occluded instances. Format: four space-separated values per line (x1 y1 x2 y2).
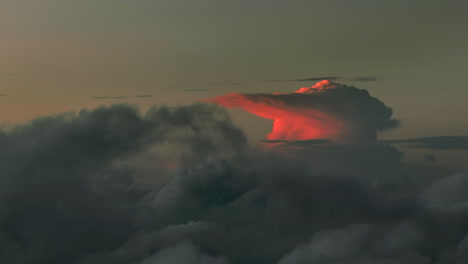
278 223 431 264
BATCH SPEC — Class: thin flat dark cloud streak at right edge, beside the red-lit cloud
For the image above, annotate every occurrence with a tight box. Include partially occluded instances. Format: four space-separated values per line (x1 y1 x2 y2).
381 136 468 150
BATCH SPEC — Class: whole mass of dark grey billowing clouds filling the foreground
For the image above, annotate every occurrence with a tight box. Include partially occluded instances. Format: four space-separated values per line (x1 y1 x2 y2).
0 104 468 264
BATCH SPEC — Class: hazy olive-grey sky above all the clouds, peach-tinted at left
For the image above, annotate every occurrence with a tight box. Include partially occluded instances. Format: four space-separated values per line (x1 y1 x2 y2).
0 0 468 142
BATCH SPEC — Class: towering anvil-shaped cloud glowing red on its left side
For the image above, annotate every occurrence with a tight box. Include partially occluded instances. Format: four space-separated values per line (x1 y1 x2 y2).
204 80 397 140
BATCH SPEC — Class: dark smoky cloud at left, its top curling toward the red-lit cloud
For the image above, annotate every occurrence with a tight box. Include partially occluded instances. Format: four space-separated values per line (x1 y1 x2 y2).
0 105 245 263
